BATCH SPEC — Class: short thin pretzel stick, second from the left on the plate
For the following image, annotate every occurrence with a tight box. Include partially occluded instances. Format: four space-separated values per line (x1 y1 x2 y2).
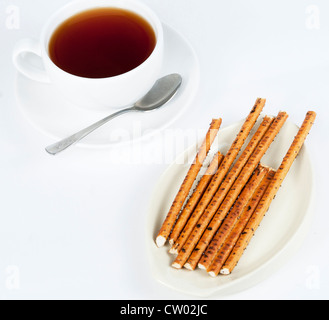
169 152 224 245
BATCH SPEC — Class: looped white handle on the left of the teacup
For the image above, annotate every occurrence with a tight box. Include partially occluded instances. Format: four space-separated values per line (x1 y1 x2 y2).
13 39 50 83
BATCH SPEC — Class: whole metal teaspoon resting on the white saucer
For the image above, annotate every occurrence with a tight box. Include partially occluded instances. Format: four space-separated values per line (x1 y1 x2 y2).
46 74 182 155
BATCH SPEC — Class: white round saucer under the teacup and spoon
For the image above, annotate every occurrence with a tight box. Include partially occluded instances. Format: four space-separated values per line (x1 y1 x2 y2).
16 25 200 147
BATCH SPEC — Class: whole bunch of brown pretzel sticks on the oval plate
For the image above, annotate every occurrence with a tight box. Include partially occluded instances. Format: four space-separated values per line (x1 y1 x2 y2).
156 99 316 277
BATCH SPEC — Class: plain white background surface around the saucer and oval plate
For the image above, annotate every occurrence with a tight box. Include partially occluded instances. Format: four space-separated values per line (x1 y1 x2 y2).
0 0 329 299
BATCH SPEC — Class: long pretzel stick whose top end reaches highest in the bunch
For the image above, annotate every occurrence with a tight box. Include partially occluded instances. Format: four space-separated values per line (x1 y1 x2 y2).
169 99 266 254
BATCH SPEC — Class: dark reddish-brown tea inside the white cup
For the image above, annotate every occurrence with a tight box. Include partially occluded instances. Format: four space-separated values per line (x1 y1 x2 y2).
49 8 156 78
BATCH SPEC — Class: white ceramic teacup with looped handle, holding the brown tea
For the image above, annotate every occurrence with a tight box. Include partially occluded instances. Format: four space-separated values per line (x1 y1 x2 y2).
13 0 164 109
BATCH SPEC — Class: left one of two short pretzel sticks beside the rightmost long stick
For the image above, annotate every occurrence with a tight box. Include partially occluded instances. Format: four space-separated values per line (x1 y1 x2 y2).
195 165 270 270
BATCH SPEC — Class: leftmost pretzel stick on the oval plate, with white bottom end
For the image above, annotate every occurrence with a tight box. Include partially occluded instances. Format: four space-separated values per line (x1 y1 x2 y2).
156 119 222 247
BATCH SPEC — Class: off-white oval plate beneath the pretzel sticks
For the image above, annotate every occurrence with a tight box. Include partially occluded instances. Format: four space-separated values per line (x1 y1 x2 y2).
146 120 313 297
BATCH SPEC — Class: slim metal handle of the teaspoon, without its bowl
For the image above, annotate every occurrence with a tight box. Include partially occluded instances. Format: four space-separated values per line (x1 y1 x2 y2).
46 107 137 155
